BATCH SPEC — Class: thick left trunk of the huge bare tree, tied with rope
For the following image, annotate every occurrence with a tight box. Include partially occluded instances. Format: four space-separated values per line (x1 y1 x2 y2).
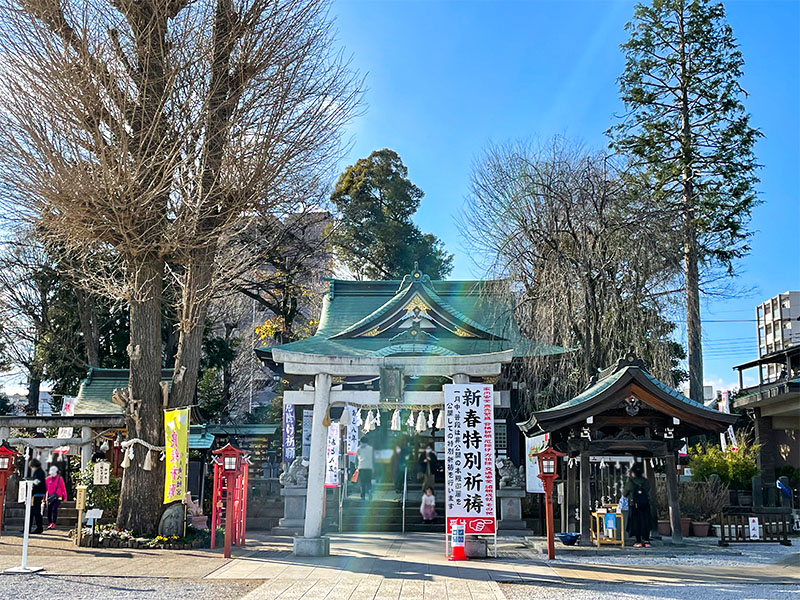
117 257 164 535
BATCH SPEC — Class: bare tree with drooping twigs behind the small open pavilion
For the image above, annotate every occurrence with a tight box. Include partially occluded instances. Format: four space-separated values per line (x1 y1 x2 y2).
462 138 682 407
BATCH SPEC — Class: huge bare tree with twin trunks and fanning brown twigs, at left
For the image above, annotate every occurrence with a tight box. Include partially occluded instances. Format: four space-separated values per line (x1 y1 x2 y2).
0 0 360 532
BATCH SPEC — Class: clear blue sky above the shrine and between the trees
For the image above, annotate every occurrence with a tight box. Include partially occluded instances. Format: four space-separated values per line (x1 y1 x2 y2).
333 0 800 389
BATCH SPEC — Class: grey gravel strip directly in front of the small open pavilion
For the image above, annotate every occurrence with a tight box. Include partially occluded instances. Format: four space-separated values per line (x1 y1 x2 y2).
553 541 800 567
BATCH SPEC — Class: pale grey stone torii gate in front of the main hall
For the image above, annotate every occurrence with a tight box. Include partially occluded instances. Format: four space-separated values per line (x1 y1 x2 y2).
272 349 512 556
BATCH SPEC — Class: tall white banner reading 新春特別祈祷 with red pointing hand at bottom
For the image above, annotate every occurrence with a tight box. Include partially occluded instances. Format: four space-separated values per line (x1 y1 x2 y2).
444 383 496 534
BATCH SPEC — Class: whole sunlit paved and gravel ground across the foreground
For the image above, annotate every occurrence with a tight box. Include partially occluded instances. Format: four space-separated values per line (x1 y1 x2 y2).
0 532 800 600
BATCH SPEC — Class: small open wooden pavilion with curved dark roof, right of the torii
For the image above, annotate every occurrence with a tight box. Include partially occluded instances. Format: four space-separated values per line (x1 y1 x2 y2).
519 354 737 543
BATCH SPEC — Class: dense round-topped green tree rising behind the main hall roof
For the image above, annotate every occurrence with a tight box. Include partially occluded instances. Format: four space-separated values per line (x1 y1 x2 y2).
331 149 453 279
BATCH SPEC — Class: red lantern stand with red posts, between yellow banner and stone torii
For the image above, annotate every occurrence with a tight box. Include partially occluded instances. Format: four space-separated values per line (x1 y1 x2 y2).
211 444 250 558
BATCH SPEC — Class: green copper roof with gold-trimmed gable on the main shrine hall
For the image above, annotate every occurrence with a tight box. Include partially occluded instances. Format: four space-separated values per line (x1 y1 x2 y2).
258 271 565 356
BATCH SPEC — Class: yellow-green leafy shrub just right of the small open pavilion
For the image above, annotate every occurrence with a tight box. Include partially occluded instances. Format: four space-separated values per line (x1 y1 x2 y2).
689 434 759 489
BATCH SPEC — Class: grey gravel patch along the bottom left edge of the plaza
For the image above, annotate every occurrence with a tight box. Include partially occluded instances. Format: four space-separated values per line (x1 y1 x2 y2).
0 574 262 600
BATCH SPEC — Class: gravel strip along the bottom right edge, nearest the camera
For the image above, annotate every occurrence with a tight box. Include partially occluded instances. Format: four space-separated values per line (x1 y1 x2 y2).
500 583 800 600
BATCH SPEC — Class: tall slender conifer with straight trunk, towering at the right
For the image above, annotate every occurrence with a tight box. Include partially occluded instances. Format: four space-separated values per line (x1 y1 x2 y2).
609 0 761 401
